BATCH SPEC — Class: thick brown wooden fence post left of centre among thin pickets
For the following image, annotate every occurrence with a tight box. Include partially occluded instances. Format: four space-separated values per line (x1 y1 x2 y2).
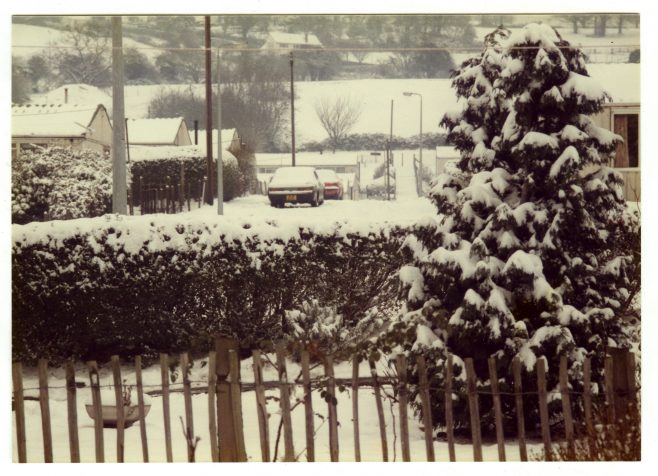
215 337 238 462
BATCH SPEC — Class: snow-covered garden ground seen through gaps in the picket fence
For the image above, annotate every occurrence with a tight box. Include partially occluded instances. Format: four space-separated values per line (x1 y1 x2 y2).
12 356 541 462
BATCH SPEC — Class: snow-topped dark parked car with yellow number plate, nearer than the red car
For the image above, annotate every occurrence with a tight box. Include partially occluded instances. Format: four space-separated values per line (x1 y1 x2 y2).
267 167 324 207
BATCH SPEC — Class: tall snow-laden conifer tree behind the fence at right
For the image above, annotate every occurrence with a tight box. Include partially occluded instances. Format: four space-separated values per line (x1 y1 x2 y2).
382 24 637 432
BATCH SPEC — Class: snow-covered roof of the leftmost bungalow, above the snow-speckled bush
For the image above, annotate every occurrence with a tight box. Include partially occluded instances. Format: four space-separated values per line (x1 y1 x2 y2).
11 104 104 137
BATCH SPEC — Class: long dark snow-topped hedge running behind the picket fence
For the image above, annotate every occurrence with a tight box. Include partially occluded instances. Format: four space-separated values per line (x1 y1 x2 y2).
12 215 405 361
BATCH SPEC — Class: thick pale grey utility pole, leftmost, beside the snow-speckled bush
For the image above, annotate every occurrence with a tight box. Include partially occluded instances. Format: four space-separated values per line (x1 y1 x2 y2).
112 16 128 215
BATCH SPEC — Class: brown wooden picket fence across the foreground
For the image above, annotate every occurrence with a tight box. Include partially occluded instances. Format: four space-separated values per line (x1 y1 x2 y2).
12 337 637 463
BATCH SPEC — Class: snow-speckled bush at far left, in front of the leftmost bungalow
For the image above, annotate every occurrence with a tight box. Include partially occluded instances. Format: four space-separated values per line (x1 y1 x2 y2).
11 147 112 223
